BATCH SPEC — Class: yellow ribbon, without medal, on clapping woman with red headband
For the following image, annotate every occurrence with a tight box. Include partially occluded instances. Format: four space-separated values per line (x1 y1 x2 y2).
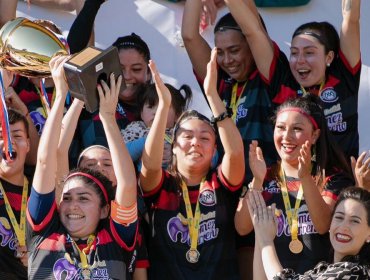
280 168 303 240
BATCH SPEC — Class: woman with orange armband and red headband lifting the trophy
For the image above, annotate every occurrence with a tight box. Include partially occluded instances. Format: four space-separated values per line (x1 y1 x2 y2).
28 57 137 280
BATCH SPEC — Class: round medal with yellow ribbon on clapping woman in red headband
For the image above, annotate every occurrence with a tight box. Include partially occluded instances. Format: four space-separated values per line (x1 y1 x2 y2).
280 167 303 254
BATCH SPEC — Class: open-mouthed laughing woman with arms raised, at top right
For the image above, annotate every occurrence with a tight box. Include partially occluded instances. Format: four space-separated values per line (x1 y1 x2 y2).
225 0 361 162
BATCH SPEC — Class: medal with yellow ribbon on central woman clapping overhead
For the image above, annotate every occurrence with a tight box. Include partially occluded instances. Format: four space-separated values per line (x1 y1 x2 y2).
181 178 205 263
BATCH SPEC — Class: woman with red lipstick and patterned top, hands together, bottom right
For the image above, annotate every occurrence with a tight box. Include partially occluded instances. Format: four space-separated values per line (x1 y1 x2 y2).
248 188 370 280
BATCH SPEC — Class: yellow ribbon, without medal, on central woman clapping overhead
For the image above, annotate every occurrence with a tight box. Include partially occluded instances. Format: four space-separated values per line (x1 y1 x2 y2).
181 178 205 255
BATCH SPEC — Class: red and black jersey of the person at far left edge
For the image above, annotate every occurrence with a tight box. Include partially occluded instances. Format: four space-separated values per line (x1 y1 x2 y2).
0 180 27 279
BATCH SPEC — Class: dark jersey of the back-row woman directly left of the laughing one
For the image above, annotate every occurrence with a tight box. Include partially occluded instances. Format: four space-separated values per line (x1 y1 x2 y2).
197 59 284 182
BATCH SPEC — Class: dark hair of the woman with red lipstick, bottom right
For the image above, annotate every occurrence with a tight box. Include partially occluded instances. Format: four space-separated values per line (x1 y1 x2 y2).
333 187 370 265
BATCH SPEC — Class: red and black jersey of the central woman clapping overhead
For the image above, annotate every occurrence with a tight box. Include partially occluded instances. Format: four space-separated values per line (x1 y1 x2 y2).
144 168 240 280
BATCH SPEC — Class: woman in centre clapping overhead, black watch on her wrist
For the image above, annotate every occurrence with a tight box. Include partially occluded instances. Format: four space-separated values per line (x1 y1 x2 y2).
140 50 245 280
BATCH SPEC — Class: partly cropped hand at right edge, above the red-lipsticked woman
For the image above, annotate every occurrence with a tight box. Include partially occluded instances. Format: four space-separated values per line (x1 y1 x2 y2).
351 151 370 191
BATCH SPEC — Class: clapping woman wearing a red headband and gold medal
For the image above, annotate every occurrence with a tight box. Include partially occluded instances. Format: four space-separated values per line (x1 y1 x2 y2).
235 95 353 273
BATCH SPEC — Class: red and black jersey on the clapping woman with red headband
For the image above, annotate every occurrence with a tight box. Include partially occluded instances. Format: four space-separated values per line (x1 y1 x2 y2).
263 166 352 274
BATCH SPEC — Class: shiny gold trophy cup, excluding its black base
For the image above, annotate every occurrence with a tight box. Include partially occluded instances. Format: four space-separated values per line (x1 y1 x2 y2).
0 17 68 78
